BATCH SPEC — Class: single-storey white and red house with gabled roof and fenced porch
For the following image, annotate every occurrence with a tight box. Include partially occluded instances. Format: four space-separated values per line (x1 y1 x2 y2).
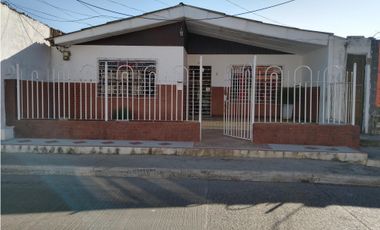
2 3 374 146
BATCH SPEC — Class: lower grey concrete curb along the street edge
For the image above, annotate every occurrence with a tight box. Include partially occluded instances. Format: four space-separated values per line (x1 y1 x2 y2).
1 165 380 187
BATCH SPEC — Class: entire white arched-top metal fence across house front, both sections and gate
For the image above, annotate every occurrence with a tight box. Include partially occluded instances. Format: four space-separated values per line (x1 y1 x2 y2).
16 57 357 139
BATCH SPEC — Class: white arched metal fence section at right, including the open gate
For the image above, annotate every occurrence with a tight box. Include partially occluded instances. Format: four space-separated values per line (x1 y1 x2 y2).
223 58 357 139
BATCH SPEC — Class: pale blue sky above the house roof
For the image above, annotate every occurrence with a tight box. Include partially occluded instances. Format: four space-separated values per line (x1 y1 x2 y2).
1 0 380 39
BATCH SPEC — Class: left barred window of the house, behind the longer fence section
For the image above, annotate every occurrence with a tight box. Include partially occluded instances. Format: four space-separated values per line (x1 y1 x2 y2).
98 59 156 97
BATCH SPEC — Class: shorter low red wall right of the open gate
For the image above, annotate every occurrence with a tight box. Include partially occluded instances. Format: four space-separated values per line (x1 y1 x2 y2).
253 123 360 148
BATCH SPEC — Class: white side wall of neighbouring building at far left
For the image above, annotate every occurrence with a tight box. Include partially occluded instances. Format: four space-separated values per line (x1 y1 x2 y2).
0 4 50 138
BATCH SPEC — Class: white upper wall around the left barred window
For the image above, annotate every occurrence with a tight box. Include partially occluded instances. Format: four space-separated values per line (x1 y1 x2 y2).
51 45 184 84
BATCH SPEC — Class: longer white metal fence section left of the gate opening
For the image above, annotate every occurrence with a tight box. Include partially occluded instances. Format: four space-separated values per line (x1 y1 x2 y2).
16 63 185 121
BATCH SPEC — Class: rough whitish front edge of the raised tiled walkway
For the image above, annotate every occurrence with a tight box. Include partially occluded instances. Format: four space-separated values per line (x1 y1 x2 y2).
1 145 368 165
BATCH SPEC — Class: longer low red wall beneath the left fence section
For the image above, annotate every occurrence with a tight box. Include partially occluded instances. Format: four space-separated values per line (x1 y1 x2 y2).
14 120 200 142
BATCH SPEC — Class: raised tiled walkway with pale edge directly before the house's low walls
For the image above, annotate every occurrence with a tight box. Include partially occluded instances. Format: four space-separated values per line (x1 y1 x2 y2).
1 136 368 165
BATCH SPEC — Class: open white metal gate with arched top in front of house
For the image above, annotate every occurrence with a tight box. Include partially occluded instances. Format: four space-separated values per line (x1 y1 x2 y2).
223 66 255 140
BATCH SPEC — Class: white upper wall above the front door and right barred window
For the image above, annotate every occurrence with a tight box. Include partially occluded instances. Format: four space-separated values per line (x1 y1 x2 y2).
187 54 302 87
